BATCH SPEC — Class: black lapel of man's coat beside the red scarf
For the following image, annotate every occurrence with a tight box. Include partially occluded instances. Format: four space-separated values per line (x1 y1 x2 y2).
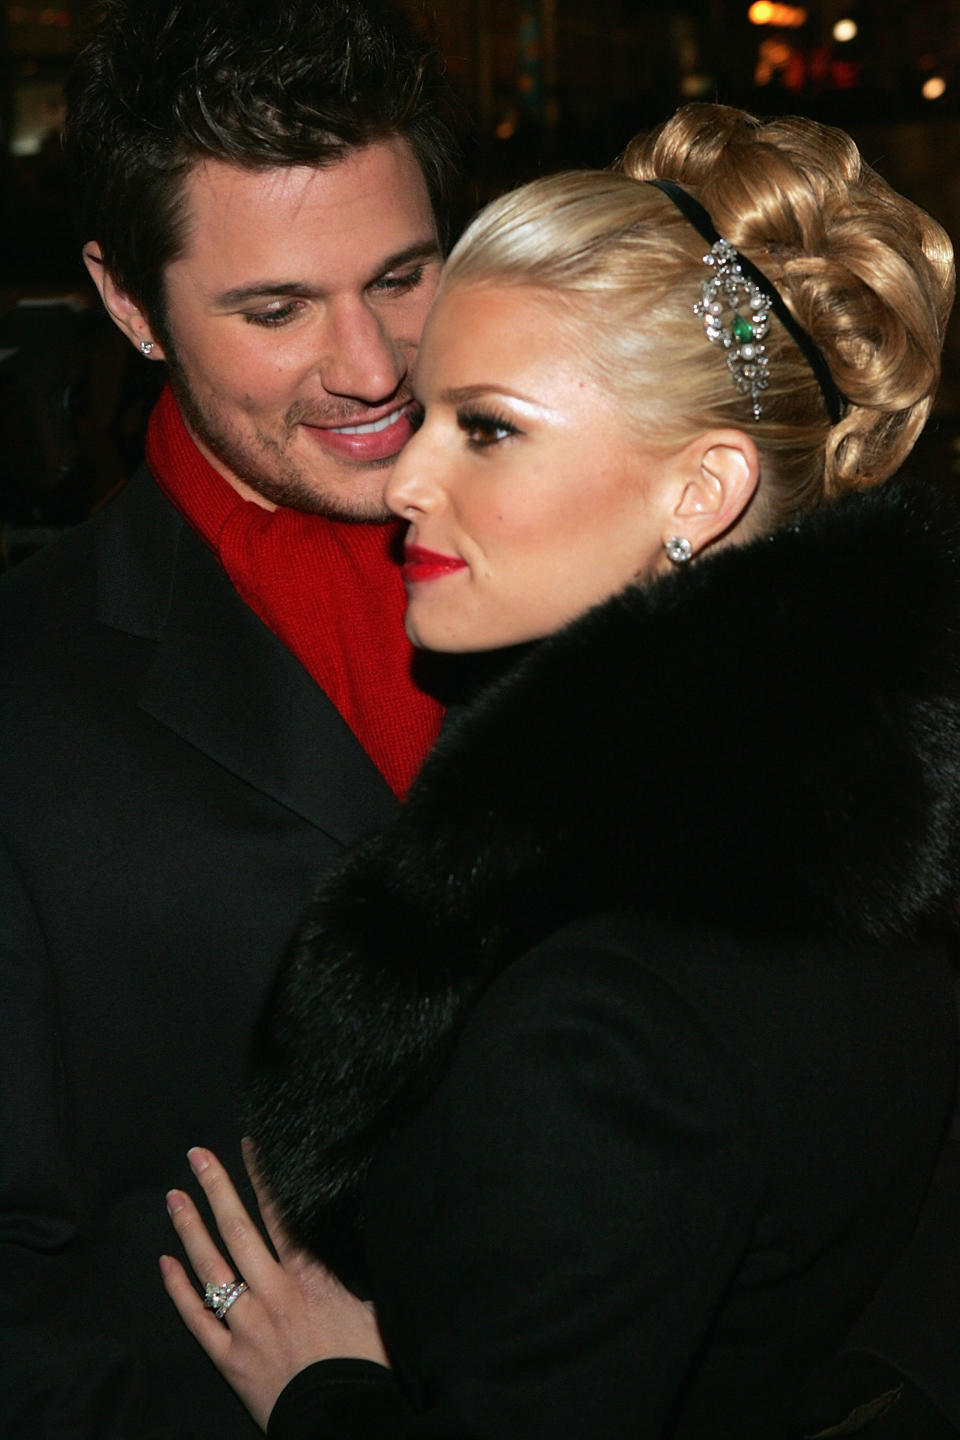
98 472 396 845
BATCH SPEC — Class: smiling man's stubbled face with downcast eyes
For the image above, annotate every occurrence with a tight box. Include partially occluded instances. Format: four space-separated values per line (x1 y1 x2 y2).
156 138 440 520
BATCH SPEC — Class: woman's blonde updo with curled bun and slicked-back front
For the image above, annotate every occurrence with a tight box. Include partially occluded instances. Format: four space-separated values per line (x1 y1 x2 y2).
443 104 953 530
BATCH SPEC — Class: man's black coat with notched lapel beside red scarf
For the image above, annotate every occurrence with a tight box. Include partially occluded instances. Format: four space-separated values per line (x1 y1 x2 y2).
0 472 394 1440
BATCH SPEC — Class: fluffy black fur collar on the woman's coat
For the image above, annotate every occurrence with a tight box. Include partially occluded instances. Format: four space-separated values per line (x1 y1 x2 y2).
250 481 960 1280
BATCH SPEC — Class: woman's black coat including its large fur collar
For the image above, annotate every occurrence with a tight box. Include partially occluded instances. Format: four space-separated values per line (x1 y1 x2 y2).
252 481 960 1440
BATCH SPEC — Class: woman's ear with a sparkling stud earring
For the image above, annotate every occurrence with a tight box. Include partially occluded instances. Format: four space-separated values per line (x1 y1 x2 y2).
664 429 760 554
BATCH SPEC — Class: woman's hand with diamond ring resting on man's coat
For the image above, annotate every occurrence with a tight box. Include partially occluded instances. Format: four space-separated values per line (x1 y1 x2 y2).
160 1149 387 1430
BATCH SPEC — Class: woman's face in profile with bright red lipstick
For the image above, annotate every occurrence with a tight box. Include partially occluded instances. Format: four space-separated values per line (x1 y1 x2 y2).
387 285 672 651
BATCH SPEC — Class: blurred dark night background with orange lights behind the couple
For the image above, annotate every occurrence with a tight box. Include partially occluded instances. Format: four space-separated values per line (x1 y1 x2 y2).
0 0 960 567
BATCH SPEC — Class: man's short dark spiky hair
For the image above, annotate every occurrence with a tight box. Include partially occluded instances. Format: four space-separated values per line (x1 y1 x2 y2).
63 0 456 338
